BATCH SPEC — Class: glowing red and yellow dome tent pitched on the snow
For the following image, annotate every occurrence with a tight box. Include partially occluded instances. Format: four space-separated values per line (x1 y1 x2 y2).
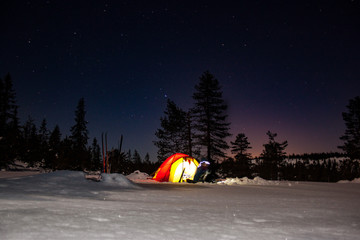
153 153 199 182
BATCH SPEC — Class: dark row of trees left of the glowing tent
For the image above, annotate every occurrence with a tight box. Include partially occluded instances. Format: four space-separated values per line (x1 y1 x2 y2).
0 74 156 174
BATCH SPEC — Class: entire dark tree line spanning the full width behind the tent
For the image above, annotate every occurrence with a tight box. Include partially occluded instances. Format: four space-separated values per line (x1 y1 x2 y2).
0 71 360 181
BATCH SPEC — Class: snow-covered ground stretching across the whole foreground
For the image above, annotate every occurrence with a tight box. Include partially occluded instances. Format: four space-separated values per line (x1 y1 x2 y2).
0 171 360 240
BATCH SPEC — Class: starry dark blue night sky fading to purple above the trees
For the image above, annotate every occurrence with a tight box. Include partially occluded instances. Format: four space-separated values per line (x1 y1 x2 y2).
0 0 360 160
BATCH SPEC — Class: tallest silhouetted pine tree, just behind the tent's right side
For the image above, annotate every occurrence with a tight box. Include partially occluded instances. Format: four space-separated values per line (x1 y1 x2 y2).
192 71 231 163
